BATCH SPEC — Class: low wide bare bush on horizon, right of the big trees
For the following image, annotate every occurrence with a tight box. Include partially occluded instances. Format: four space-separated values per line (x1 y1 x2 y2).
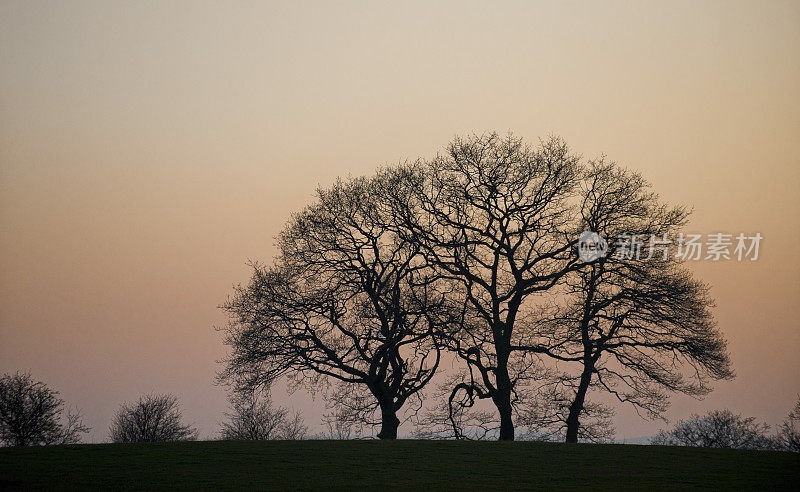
651 410 779 449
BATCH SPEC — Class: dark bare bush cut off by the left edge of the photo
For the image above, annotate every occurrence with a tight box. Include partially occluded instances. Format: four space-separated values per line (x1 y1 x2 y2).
0 372 89 446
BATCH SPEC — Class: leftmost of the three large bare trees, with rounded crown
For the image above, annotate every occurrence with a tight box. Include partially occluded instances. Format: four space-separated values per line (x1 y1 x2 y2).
220 173 450 439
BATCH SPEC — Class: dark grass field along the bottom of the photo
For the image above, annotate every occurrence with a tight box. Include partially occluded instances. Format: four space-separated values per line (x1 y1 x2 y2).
0 440 800 490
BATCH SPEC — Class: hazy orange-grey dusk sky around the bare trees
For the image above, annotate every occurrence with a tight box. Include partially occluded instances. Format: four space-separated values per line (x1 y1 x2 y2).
0 0 800 440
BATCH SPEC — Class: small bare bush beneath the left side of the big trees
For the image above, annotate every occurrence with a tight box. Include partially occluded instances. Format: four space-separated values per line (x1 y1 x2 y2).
220 391 307 441
